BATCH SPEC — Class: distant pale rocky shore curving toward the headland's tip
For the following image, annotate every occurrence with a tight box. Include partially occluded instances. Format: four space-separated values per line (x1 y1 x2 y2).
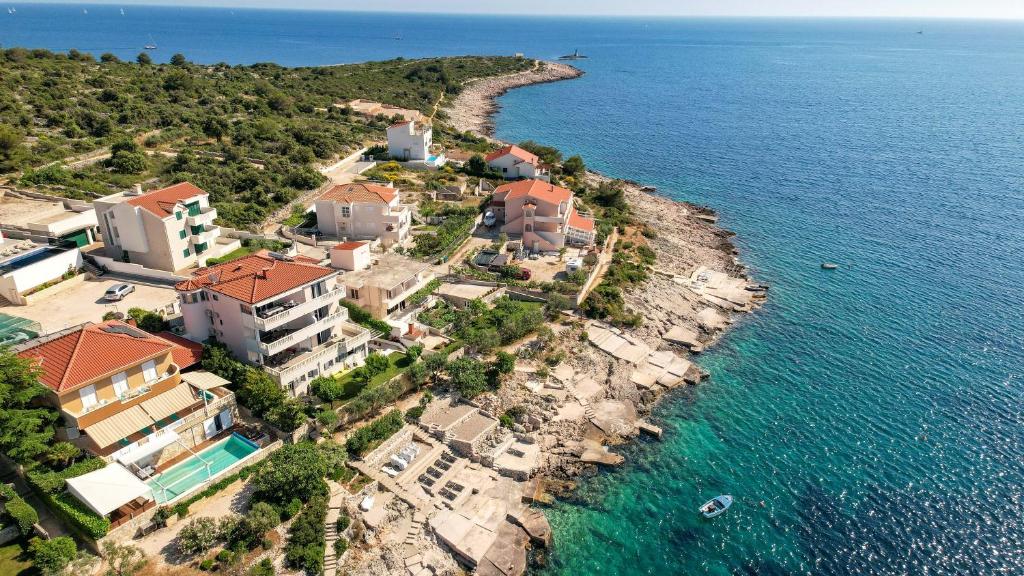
445 60 583 137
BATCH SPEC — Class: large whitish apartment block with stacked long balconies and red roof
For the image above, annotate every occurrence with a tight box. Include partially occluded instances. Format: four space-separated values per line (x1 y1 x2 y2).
175 250 370 396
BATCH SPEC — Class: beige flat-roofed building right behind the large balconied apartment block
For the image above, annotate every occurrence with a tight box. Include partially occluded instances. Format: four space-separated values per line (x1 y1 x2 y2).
338 252 434 320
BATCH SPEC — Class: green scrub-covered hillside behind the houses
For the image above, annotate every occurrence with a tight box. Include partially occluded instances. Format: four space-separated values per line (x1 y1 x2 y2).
0 48 530 228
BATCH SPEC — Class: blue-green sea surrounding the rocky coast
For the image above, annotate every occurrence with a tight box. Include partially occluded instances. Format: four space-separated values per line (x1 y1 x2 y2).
0 4 1024 575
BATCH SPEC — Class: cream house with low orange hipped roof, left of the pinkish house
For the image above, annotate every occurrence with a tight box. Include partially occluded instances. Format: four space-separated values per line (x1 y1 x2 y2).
314 182 413 248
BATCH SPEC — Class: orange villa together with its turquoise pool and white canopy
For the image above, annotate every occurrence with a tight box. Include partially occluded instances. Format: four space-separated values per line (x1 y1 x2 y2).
14 320 263 528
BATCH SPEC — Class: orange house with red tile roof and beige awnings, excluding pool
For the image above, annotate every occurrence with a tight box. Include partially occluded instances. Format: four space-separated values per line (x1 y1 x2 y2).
13 320 237 470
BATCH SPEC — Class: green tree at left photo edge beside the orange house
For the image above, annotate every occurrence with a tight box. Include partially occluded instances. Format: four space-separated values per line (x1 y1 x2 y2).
0 348 57 461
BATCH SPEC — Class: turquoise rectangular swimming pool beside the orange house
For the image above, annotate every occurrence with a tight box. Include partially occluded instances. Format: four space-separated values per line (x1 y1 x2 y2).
147 434 259 504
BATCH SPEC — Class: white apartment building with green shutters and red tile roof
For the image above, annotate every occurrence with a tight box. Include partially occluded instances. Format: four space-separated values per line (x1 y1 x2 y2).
93 182 220 272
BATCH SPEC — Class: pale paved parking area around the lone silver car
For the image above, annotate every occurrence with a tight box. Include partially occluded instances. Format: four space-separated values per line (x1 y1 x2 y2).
0 279 178 333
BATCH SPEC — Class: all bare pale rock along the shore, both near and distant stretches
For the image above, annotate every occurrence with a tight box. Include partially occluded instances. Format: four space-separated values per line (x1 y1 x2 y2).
331 63 766 575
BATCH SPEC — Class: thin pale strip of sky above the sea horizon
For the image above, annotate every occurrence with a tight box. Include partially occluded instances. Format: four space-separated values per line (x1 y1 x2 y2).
23 0 1024 19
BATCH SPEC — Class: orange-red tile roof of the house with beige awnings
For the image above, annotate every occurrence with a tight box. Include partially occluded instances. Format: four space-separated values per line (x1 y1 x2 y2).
17 320 174 393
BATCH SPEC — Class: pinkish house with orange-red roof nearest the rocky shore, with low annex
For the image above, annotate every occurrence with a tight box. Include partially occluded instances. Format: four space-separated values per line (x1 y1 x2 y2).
488 179 596 252
